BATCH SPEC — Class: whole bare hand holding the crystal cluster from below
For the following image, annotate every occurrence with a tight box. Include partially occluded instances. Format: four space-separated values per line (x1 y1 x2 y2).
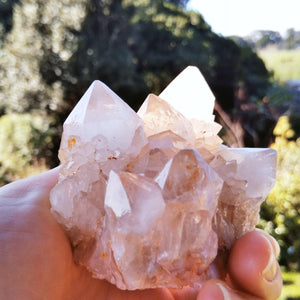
0 168 282 300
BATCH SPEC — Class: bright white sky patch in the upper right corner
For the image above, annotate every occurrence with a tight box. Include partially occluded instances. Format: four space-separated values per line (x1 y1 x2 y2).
189 0 300 36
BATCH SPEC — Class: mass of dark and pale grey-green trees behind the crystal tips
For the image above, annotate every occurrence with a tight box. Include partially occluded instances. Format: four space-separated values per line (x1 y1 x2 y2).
0 0 269 171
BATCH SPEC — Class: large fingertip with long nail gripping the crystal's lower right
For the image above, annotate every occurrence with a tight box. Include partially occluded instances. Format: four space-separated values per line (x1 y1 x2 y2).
228 230 282 300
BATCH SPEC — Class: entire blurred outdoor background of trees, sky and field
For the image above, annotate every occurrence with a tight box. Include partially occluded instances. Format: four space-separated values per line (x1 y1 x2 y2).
0 0 300 299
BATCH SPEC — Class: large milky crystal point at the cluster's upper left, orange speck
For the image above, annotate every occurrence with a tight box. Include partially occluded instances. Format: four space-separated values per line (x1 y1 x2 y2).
59 81 147 176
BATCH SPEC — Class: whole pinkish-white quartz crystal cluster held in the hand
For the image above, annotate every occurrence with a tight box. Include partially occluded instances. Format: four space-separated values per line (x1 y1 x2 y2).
50 67 276 290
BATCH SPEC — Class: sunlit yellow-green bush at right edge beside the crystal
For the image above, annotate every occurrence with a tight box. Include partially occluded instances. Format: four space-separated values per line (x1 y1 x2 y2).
261 116 300 270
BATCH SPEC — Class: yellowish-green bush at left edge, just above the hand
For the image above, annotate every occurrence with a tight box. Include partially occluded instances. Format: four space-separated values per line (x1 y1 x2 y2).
0 114 53 185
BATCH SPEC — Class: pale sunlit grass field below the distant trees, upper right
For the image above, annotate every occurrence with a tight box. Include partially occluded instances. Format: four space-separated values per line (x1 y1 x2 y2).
258 48 300 81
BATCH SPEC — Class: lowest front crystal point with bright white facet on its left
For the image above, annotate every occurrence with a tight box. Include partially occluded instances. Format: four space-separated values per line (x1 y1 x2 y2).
105 171 165 235
